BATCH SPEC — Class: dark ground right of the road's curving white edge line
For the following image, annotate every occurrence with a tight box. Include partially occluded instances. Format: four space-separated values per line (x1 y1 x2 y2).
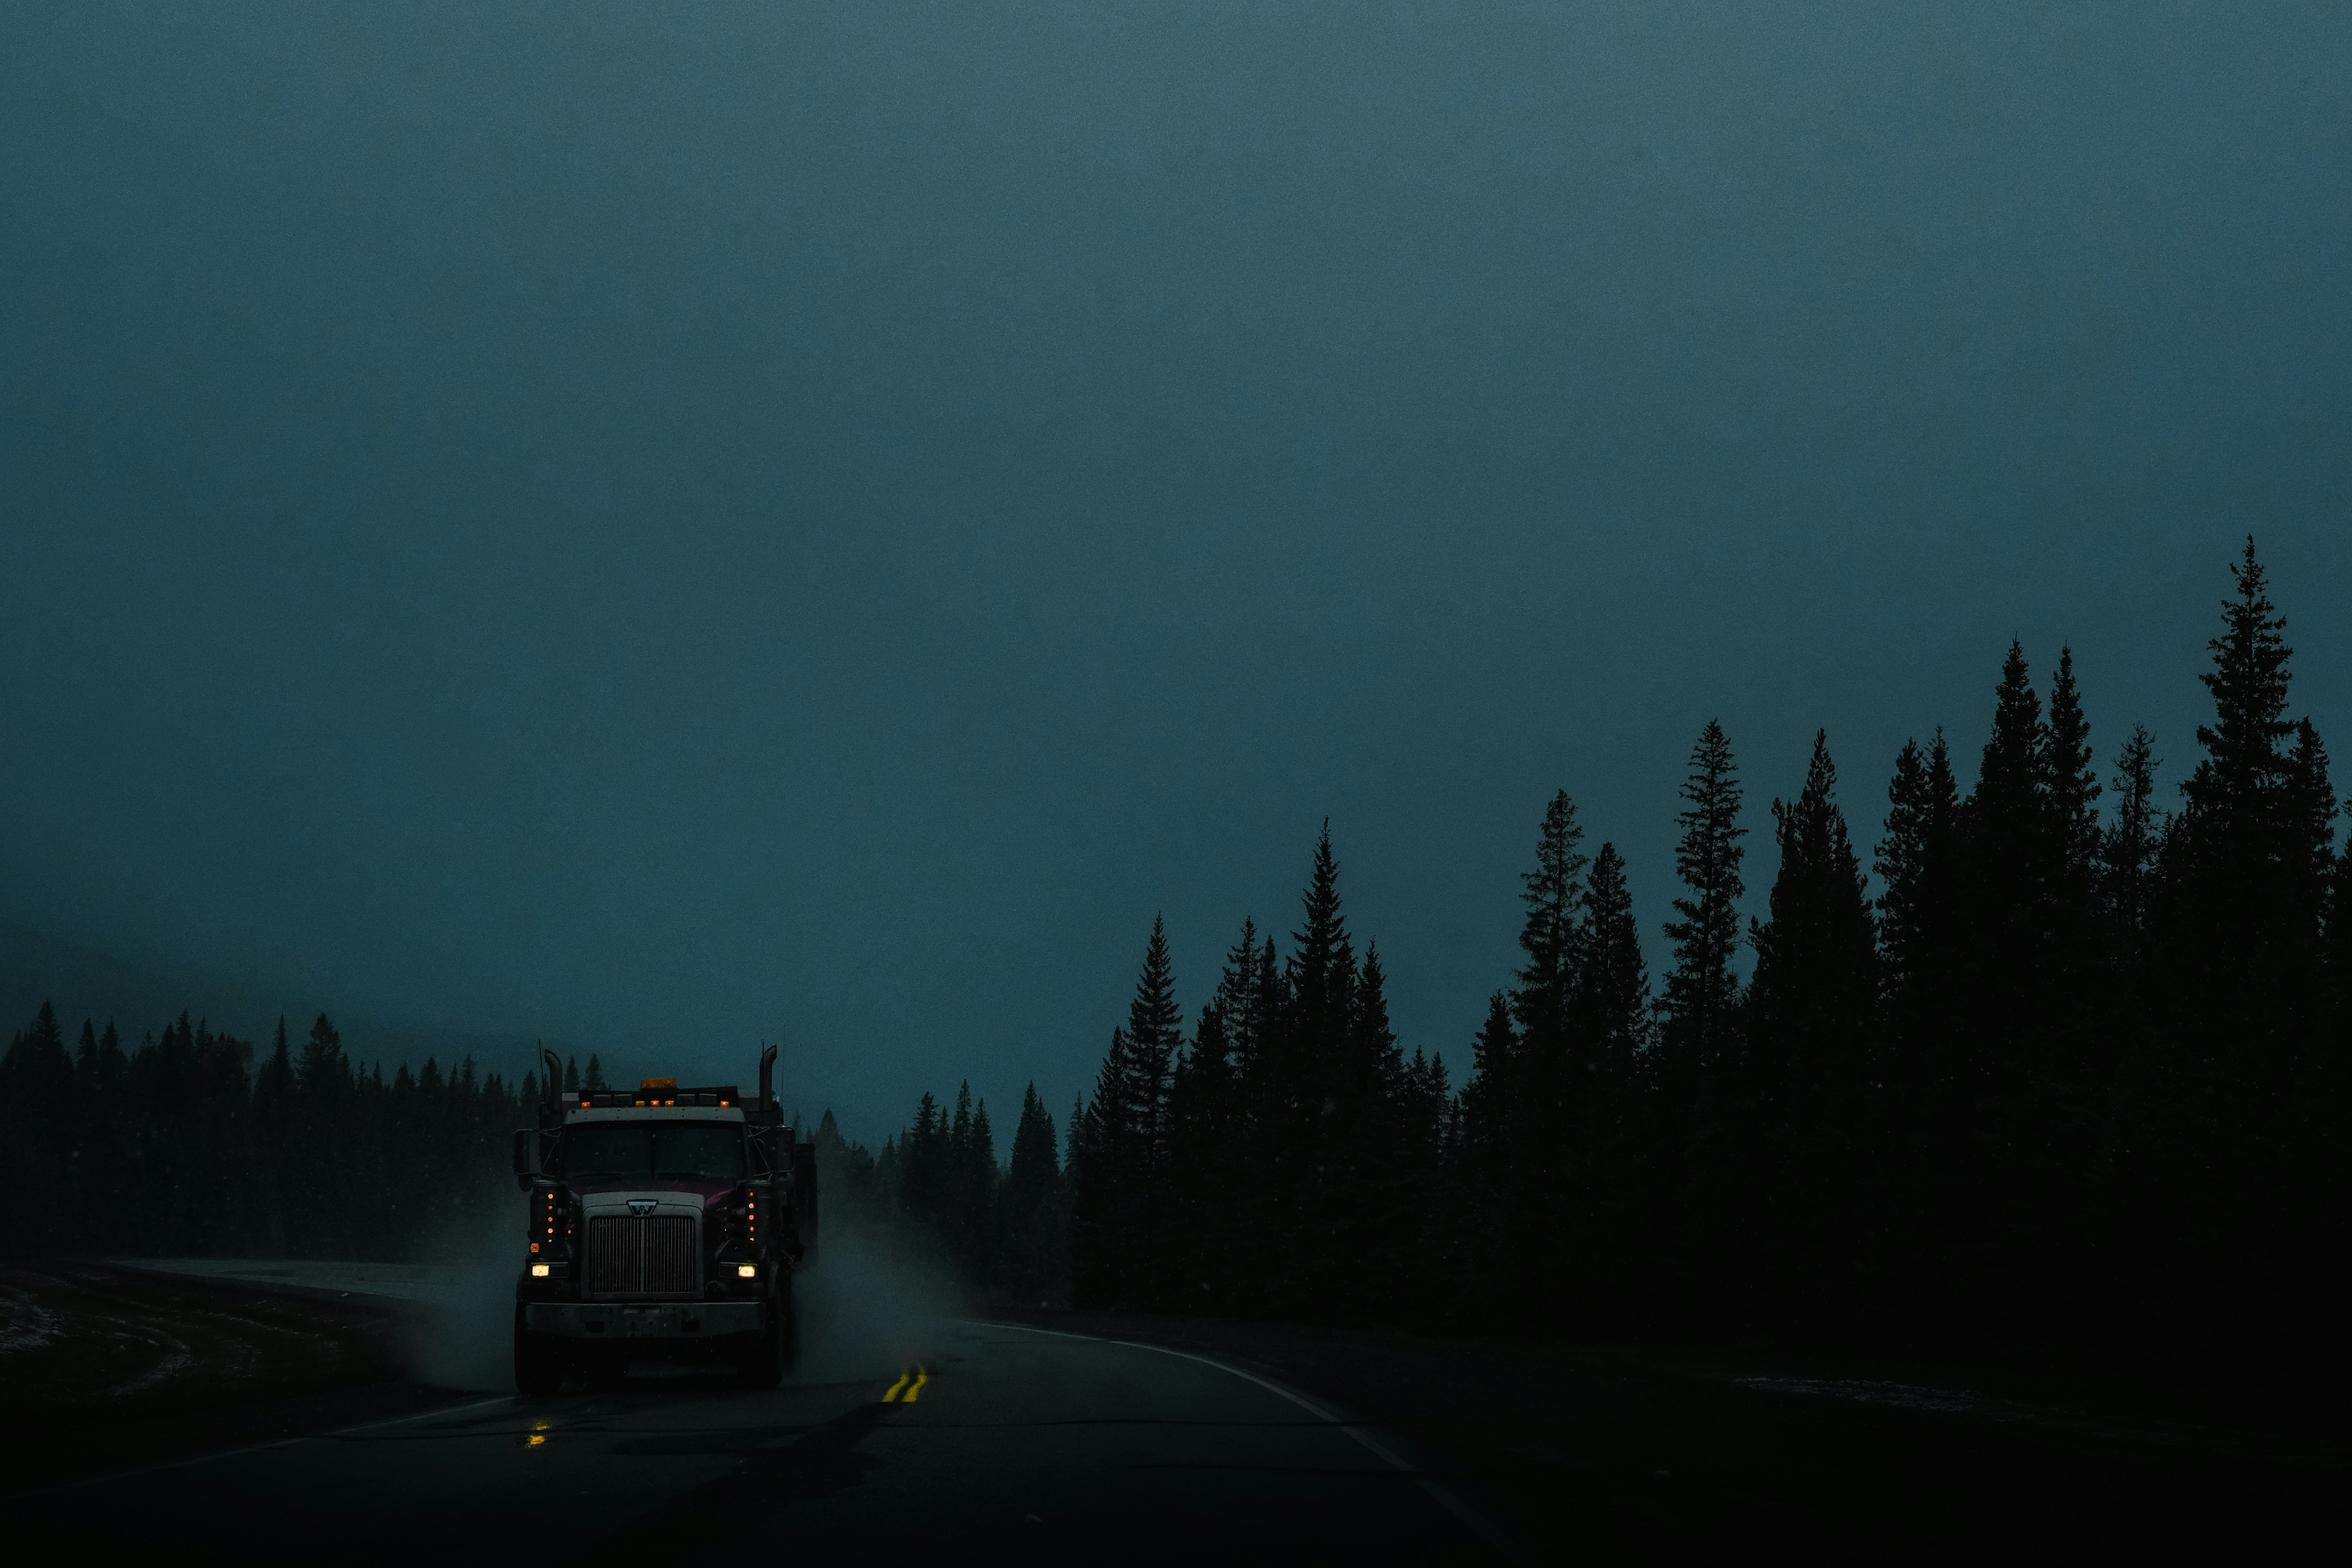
997 1312 2352 1561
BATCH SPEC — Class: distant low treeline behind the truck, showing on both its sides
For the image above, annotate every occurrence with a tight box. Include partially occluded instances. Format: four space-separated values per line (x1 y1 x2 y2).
0 982 1070 1302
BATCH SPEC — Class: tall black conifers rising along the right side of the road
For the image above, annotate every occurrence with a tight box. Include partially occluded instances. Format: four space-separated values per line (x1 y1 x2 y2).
1073 543 2352 1363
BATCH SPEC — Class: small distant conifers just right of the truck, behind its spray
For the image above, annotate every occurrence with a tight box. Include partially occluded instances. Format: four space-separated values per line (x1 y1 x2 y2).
816 1084 1070 1302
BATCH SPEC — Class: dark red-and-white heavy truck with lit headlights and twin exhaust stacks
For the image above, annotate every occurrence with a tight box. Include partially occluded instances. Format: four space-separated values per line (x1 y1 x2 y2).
515 1046 816 1394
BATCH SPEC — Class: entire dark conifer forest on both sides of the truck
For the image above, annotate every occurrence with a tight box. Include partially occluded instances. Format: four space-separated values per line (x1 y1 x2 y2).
0 541 2352 1361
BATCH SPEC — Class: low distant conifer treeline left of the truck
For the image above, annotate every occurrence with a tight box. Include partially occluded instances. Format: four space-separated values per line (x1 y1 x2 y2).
0 1020 586 1262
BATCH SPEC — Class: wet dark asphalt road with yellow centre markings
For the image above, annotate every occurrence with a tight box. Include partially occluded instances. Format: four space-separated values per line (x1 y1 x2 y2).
27 1321 1515 1566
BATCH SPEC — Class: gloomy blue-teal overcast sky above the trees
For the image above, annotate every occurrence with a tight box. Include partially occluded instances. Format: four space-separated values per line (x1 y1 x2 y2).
0 0 2352 1138
